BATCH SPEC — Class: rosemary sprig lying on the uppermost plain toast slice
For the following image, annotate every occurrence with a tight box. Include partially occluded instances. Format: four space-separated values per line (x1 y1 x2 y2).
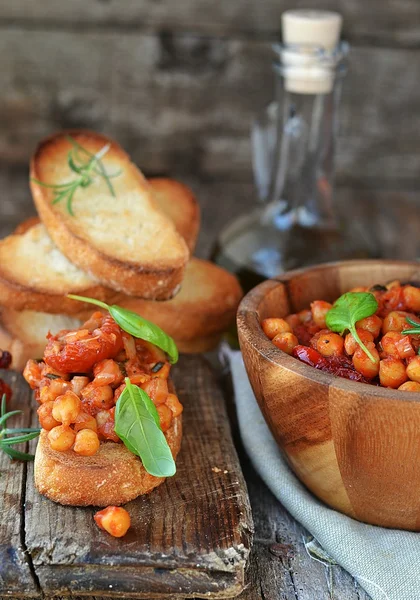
31 136 122 217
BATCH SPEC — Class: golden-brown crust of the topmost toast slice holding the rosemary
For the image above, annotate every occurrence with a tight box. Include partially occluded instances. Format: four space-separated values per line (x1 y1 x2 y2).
30 130 189 300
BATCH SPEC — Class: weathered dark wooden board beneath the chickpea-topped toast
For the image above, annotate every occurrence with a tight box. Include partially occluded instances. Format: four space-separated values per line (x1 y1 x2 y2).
0 356 253 598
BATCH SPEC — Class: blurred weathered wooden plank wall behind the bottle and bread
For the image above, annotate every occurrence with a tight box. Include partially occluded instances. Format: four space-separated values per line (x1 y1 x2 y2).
0 0 420 197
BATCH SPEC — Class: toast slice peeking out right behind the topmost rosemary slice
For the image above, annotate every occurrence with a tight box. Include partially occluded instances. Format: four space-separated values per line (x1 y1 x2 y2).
147 177 200 254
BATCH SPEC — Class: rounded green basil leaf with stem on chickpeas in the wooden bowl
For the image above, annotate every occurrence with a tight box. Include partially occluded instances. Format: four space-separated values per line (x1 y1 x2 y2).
325 292 378 362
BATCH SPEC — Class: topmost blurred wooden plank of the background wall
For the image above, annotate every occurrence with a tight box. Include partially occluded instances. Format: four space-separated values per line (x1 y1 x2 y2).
0 0 420 45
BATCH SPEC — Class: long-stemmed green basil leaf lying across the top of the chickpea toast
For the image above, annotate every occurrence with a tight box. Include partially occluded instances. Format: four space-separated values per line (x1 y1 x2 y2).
67 294 178 364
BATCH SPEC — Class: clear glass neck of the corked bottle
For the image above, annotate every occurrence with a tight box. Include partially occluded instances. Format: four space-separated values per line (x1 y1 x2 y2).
263 41 345 229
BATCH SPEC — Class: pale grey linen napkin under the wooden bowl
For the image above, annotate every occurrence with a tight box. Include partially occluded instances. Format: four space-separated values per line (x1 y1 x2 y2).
229 351 420 600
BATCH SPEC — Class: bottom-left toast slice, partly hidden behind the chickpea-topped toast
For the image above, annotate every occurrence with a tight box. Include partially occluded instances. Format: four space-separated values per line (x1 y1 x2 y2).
0 309 81 371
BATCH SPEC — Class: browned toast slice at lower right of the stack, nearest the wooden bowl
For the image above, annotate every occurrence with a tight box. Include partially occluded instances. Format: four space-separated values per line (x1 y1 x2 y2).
100 258 243 352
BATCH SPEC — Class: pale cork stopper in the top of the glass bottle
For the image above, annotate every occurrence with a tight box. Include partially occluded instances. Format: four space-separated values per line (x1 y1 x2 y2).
282 10 343 94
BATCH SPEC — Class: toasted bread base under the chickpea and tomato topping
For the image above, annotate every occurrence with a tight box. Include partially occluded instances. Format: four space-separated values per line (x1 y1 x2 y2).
35 416 182 506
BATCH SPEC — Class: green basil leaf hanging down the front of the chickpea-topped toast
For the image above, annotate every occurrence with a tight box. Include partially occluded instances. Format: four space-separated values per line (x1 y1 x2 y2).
115 378 176 477
